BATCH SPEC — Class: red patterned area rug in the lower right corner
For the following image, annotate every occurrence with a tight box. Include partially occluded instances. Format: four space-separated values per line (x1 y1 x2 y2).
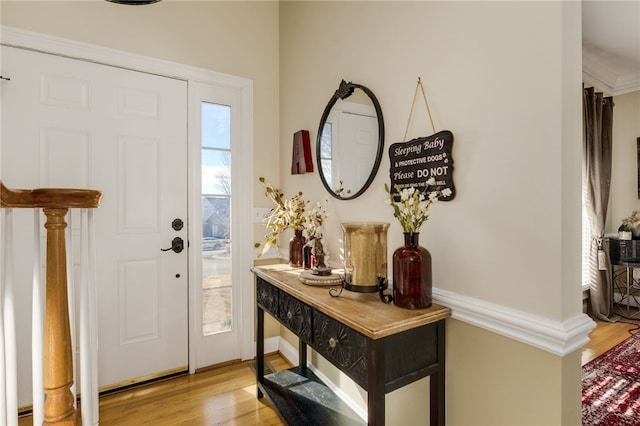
582 334 640 426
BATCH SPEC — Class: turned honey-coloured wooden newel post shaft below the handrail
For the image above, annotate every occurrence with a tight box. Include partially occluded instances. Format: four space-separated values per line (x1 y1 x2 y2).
43 208 76 426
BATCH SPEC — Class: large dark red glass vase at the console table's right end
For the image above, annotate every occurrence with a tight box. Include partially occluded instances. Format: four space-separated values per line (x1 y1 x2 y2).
393 232 433 309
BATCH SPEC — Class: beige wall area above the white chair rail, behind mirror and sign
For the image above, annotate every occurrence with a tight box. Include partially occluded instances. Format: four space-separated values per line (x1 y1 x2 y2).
280 2 581 320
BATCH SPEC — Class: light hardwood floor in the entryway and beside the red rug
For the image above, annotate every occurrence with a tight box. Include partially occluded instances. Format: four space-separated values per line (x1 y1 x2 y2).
19 321 638 426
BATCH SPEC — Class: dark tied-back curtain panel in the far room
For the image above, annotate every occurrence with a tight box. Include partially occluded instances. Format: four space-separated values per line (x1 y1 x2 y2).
582 88 614 321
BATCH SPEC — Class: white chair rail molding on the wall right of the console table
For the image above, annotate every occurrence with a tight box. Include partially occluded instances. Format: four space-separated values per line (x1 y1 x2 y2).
433 288 596 356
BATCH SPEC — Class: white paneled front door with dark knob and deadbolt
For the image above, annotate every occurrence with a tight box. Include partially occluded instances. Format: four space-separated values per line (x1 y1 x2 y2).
1 46 188 405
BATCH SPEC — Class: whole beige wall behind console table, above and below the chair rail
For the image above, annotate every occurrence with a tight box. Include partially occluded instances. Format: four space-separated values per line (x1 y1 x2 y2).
280 2 581 425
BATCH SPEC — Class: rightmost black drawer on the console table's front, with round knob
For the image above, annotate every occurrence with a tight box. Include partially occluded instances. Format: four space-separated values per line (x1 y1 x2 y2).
312 311 368 389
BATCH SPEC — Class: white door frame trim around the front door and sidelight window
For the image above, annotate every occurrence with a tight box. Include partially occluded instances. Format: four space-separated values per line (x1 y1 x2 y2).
0 26 255 373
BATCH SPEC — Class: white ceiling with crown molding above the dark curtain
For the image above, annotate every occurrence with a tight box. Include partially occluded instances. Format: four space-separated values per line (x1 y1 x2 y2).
582 0 640 95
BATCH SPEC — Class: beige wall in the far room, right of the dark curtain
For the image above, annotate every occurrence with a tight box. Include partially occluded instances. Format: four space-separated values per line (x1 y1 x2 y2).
606 91 640 233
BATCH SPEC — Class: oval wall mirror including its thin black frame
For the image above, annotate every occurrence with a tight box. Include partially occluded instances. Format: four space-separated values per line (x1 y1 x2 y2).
316 80 384 200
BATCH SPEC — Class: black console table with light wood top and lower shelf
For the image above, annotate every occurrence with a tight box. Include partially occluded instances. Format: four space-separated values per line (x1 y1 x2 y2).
253 265 451 426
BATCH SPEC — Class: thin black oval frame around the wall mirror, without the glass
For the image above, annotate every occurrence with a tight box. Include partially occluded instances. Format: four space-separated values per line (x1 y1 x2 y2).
316 80 384 200
